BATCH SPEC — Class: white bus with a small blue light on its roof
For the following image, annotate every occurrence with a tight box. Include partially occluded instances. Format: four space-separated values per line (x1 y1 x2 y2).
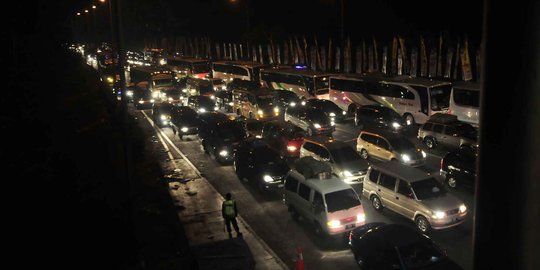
261 69 332 99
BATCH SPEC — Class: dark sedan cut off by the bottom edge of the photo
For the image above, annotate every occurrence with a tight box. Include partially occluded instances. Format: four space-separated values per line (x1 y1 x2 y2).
349 222 463 270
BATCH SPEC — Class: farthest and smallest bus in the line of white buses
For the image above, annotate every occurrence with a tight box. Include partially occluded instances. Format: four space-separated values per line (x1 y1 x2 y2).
166 56 212 79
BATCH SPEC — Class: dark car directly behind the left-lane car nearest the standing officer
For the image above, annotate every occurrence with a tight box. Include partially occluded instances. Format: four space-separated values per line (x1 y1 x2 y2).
199 112 247 164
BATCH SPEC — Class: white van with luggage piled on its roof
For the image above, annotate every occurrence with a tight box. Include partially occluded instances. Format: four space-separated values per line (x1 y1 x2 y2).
283 157 366 236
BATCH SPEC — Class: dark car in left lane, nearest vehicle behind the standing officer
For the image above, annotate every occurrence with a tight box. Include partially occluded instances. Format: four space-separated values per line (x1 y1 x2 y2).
233 138 289 191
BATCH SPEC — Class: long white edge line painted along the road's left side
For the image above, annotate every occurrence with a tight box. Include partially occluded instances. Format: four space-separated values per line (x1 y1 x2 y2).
141 111 289 269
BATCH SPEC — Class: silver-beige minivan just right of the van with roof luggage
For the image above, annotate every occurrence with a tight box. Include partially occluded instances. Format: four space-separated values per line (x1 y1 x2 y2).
362 162 467 233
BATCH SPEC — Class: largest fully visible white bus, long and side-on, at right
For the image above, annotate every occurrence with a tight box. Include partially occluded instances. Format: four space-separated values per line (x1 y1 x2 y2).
330 75 452 123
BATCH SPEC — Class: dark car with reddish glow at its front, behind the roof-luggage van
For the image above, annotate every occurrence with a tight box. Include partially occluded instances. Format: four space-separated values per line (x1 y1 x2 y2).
261 120 306 158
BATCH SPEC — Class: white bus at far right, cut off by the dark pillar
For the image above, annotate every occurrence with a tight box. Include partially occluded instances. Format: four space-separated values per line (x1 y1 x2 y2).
448 82 480 127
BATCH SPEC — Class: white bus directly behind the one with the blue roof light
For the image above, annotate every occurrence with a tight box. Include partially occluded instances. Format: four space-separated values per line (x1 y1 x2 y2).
212 61 269 83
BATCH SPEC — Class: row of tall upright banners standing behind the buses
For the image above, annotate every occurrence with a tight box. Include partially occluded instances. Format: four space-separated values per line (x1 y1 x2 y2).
145 34 480 81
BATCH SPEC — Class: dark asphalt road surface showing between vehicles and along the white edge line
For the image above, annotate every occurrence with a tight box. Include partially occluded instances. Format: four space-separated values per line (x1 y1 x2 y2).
130 105 474 269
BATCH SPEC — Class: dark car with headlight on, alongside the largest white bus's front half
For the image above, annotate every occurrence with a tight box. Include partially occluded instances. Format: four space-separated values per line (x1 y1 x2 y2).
354 105 407 132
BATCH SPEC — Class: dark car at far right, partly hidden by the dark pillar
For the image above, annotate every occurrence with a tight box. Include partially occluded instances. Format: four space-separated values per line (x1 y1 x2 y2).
441 148 477 189
